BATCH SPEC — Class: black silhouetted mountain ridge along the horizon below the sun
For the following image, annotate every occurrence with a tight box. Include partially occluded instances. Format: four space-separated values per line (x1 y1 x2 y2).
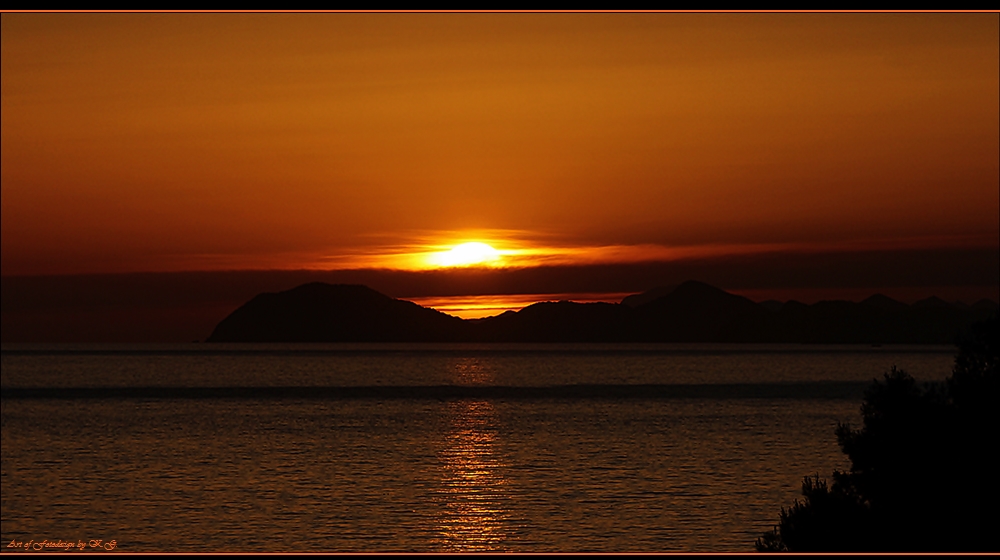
206 281 1000 344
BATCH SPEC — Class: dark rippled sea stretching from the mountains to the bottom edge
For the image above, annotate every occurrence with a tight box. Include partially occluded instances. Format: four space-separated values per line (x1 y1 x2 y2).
0 343 955 552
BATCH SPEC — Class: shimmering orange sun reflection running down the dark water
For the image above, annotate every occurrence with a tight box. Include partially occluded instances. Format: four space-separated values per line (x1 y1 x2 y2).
438 359 510 551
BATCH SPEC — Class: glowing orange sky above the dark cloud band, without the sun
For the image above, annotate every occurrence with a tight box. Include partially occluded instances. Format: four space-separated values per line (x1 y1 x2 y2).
0 13 1000 276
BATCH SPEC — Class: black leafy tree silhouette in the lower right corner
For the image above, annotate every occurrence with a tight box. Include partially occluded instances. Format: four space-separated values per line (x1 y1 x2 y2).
756 316 1000 552
